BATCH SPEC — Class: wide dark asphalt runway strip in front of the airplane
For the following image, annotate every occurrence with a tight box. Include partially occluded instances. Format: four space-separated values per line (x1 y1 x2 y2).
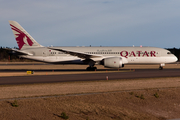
0 69 180 85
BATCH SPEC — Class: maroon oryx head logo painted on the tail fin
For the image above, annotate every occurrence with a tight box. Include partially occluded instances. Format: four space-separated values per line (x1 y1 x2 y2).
11 25 33 50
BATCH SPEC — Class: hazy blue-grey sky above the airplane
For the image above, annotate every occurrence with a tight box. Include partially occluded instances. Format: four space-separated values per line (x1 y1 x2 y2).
0 0 180 48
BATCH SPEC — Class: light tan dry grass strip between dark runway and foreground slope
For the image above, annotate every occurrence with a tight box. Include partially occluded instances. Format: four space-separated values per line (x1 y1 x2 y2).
0 77 180 99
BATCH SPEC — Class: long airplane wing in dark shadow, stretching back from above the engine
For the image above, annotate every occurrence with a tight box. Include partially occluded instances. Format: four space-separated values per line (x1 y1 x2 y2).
48 47 102 59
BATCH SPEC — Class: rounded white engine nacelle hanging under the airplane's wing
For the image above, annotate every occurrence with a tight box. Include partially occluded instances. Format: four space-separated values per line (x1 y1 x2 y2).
101 57 124 68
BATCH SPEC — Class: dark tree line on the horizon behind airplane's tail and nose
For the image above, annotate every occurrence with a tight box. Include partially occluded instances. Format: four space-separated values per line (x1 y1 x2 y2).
0 47 180 62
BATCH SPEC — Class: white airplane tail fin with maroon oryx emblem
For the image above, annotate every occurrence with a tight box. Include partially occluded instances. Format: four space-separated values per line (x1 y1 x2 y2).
9 21 42 50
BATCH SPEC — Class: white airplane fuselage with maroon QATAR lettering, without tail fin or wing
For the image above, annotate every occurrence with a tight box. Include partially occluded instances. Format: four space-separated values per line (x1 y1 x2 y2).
21 47 177 64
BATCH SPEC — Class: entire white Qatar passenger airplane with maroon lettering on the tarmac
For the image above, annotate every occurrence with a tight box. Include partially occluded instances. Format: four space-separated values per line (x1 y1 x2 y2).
9 21 177 71
